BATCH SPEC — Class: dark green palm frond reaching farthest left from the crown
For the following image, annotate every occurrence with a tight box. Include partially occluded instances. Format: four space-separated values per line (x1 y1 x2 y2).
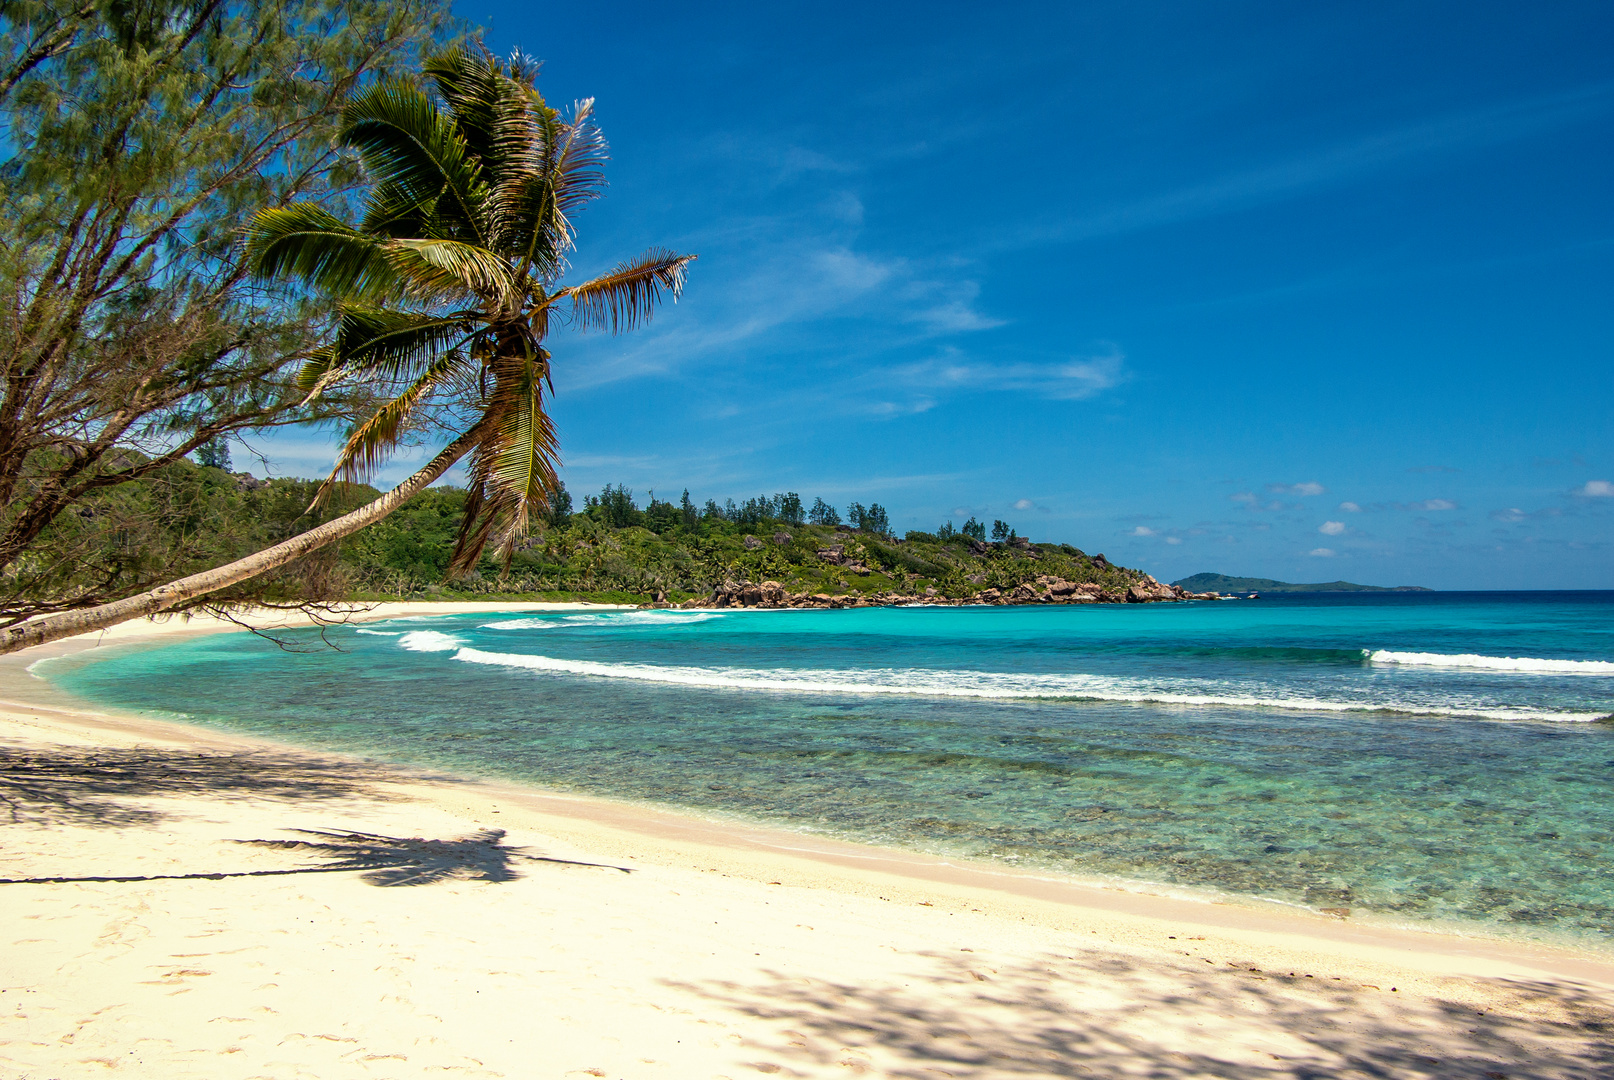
247 203 397 295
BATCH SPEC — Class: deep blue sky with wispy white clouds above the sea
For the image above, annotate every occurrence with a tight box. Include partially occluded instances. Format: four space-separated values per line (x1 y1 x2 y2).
237 0 1614 589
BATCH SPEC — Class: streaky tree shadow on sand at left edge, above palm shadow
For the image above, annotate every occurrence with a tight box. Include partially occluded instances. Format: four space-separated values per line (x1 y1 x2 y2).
0 747 409 827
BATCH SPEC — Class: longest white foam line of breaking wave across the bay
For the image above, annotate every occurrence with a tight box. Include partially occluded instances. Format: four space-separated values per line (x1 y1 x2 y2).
435 647 1601 722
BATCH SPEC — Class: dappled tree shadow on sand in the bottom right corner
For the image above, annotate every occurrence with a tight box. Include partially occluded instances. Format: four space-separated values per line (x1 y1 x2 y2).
676 954 1614 1080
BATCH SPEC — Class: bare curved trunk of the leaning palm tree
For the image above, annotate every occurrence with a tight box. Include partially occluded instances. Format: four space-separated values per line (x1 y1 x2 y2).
0 423 486 654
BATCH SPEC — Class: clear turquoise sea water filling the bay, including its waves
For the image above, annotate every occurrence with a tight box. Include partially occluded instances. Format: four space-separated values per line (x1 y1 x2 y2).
40 592 1614 946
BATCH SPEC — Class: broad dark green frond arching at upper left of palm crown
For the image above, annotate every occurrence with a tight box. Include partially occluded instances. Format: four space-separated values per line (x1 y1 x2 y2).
342 79 487 242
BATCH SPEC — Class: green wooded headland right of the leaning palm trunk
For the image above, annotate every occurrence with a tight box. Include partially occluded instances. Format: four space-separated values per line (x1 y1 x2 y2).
341 488 1165 604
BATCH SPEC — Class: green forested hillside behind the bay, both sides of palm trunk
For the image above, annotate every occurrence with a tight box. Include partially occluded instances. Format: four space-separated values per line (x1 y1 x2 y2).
6 452 1187 604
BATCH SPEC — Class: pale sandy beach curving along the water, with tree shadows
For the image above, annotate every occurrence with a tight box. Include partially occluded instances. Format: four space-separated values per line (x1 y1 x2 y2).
0 604 1614 1080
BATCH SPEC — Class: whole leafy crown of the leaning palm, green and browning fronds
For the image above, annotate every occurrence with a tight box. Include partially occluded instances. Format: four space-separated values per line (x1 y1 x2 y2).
247 50 694 575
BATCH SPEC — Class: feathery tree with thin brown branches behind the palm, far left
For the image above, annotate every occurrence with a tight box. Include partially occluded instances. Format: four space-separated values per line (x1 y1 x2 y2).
0 0 454 626
